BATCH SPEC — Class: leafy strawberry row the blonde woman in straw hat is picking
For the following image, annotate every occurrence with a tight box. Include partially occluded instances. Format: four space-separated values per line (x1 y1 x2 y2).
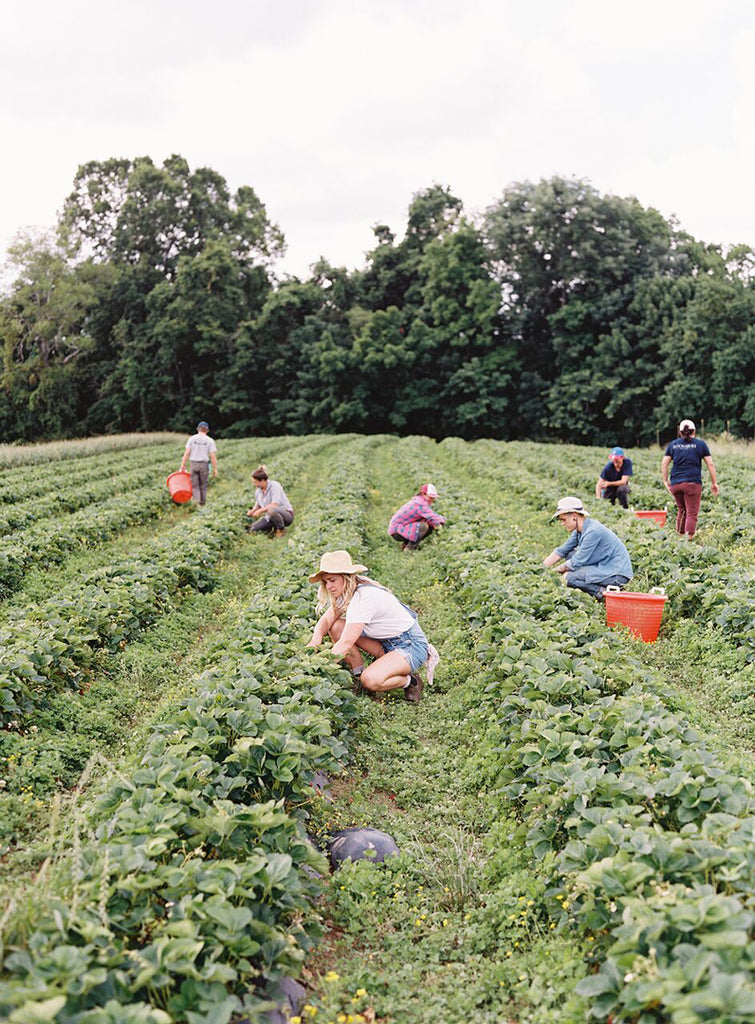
0 441 376 1024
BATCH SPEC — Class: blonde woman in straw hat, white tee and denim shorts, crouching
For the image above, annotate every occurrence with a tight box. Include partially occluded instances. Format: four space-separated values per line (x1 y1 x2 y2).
309 551 438 702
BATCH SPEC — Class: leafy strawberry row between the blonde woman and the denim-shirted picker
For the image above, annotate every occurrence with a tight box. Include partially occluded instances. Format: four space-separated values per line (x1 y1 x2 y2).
424 440 755 1024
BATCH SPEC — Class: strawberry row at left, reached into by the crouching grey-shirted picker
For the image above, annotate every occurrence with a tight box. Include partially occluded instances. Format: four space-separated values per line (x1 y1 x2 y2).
0 439 328 725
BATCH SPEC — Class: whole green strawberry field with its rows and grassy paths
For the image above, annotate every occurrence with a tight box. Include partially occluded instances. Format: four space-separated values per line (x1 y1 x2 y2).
0 435 755 1024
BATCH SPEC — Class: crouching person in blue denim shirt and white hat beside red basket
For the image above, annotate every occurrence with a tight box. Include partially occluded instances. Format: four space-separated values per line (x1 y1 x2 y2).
543 497 634 601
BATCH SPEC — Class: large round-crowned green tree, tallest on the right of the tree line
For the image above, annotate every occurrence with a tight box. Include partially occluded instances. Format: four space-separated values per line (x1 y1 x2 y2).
486 178 691 438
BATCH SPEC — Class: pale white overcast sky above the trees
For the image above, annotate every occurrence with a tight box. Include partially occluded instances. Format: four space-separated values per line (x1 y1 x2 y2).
0 0 755 275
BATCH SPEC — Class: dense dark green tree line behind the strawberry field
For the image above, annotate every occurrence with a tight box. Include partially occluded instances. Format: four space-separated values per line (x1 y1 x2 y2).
0 156 755 444
